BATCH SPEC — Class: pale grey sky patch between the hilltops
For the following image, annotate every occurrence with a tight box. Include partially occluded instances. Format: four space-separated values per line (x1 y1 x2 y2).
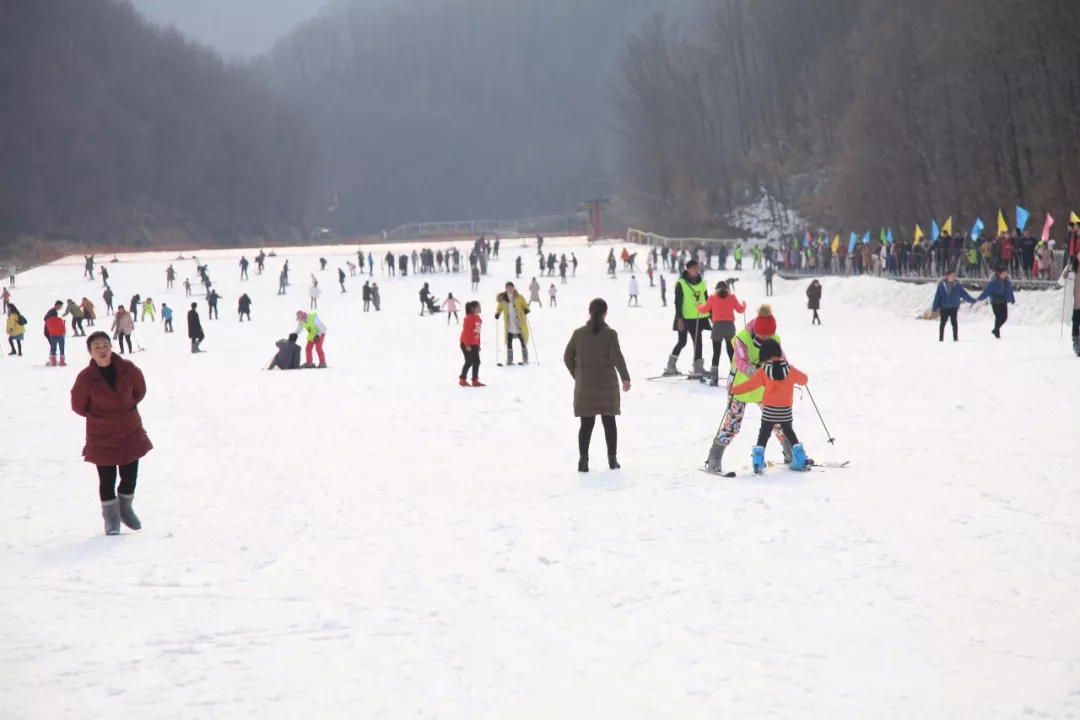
132 0 327 57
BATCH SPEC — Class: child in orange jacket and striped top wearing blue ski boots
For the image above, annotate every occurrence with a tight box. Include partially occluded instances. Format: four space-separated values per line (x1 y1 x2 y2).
731 340 811 475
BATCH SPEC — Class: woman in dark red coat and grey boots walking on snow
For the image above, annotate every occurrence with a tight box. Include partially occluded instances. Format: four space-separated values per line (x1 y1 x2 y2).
71 332 153 535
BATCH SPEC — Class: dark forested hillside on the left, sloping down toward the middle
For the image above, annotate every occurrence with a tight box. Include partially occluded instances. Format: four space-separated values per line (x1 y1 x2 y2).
0 0 313 250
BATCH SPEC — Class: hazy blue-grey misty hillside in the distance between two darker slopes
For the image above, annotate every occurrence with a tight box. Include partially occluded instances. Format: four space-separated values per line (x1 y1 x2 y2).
262 0 697 232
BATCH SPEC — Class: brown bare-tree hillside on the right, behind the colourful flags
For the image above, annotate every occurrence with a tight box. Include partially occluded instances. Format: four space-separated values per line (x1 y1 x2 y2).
620 0 1080 236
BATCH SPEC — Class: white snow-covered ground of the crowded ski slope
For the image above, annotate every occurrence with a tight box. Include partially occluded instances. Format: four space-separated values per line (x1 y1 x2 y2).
0 239 1080 720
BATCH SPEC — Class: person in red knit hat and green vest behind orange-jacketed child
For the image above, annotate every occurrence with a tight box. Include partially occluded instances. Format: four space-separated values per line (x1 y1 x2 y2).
705 305 792 475
